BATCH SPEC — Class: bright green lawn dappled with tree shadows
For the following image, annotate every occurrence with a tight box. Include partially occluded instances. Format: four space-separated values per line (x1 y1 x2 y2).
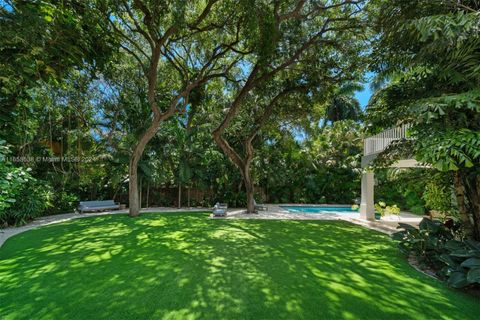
0 214 480 320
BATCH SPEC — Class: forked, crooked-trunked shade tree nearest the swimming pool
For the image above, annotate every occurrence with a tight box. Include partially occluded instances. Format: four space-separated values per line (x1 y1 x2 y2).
213 1 362 213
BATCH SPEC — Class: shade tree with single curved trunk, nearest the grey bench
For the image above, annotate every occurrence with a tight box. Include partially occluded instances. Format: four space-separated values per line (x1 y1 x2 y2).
100 0 251 216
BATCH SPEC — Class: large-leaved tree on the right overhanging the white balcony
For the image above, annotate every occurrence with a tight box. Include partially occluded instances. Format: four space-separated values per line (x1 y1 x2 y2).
367 1 480 239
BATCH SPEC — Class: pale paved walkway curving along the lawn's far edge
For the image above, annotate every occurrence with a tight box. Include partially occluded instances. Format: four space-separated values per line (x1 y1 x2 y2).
0 205 422 247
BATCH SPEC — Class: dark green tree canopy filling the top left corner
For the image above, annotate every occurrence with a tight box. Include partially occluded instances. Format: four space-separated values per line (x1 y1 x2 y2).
0 0 114 146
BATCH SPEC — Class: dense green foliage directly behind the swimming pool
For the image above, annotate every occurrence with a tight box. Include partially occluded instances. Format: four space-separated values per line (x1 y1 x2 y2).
256 121 362 203
